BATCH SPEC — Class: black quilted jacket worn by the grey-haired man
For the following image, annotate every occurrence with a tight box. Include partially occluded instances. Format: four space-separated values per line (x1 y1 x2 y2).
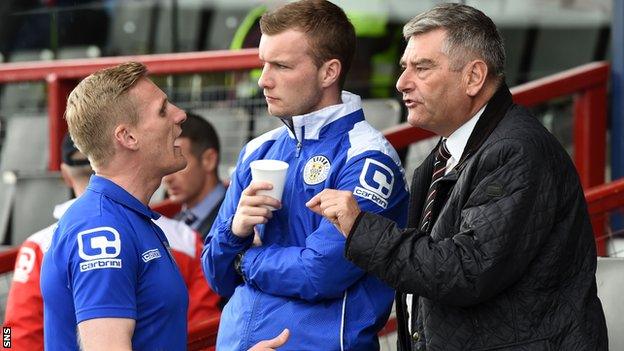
346 85 607 351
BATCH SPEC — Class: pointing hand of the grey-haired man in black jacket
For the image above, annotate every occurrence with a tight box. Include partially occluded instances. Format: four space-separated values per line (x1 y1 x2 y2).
306 189 362 237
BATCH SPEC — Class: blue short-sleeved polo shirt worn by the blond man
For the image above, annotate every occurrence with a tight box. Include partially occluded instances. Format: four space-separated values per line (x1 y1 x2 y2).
41 176 188 350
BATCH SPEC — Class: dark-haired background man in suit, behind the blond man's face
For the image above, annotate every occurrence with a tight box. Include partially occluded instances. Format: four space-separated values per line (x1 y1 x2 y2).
163 112 225 238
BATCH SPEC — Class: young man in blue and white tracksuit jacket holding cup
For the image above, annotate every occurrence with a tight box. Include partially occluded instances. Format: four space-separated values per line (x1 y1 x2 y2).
202 0 407 350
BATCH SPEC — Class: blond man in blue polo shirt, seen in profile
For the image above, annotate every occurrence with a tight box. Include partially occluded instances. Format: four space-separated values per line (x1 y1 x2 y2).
41 63 188 350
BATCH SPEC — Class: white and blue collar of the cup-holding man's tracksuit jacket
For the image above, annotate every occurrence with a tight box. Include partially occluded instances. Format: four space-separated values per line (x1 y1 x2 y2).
288 90 364 141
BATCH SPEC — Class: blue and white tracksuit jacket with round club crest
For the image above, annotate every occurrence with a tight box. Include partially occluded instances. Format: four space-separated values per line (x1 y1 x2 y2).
202 92 408 350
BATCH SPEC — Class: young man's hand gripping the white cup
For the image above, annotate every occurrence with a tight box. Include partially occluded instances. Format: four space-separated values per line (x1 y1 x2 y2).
232 182 282 238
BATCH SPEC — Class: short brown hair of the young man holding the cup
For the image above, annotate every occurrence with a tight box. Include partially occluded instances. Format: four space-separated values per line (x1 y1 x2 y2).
260 0 355 88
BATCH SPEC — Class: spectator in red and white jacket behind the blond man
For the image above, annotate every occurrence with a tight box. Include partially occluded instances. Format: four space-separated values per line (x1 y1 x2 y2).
4 135 220 350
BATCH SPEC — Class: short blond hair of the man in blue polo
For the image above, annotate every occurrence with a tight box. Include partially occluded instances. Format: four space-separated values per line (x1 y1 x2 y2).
65 62 147 168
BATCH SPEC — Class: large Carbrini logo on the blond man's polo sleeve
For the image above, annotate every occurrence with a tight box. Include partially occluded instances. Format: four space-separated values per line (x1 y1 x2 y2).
78 227 121 272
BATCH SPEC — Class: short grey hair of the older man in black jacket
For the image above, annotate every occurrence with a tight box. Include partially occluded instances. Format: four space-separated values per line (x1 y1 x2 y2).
403 3 505 79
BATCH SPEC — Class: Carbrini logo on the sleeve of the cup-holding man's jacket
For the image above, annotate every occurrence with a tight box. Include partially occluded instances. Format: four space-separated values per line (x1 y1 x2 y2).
353 158 394 208
